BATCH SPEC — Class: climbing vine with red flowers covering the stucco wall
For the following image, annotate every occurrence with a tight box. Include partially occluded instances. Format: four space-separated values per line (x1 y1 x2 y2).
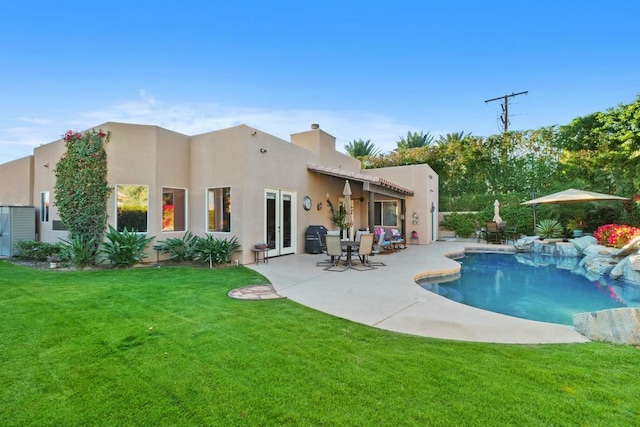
54 129 112 251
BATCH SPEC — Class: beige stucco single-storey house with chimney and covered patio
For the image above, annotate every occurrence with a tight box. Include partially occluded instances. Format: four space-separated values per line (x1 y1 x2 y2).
0 122 438 263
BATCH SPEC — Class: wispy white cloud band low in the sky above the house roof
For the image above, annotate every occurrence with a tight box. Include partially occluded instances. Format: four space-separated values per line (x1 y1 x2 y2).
0 89 433 163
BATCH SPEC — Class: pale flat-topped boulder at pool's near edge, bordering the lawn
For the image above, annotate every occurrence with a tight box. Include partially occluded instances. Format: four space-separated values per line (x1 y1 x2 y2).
573 308 640 345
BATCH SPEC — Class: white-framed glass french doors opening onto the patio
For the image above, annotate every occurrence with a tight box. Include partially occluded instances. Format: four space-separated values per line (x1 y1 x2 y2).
264 188 296 257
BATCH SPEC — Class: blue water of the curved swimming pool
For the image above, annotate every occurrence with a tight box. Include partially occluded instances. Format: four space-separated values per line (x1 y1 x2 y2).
419 254 640 325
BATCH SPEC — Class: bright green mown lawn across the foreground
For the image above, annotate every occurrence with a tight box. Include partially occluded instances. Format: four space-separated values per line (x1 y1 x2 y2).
0 262 640 426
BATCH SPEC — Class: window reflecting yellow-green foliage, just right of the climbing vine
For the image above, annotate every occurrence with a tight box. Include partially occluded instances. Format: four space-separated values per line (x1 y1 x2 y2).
116 184 149 233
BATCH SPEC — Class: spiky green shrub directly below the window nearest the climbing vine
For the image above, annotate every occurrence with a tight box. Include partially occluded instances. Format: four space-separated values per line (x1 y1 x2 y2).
100 226 153 267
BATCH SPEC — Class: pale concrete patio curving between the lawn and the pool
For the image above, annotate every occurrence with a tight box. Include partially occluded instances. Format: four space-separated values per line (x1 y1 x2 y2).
247 241 588 344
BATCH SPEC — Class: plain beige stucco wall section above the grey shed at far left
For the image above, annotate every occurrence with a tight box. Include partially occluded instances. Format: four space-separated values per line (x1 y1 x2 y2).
0 156 34 206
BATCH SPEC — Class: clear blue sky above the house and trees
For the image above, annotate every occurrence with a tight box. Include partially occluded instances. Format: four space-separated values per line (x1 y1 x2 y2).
0 0 640 163
